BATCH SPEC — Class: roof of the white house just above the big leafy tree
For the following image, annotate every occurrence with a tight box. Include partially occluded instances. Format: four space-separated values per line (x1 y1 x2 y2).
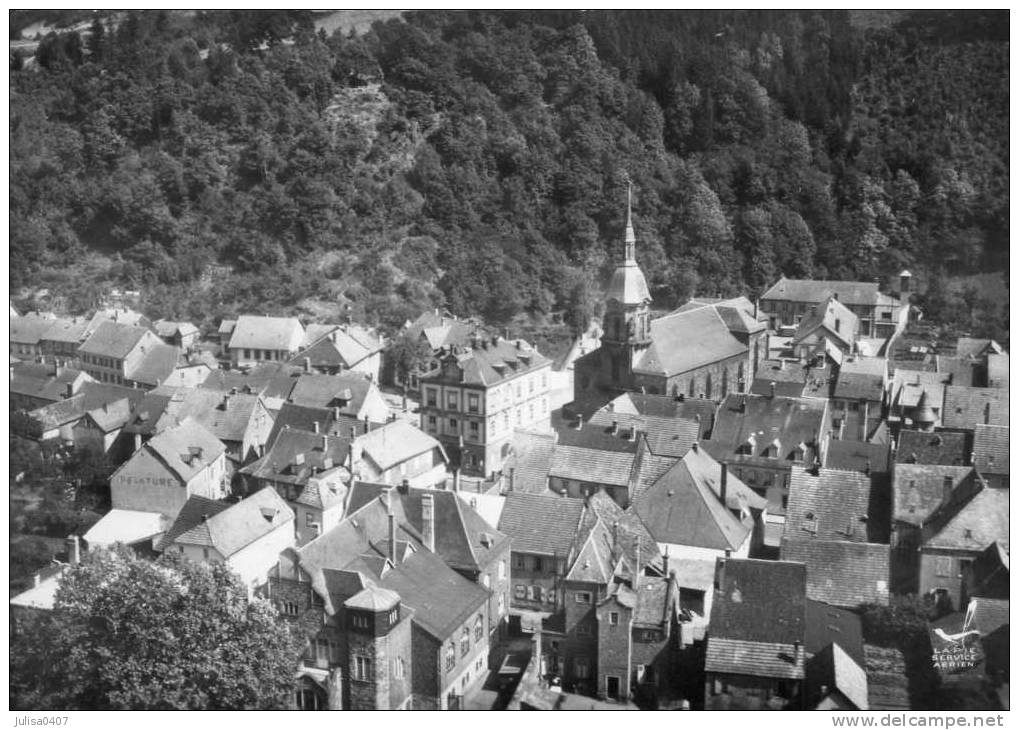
161 486 293 560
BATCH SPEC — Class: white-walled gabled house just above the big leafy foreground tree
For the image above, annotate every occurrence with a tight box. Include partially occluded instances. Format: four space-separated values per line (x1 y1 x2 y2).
155 488 294 592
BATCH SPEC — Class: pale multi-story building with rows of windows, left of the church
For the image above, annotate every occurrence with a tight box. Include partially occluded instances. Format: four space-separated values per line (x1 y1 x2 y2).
421 337 551 477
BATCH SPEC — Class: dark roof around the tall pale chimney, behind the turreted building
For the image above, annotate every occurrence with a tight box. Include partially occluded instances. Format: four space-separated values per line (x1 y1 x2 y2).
346 481 508 571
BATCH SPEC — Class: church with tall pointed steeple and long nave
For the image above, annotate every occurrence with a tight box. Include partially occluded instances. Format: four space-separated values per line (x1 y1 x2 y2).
574 199 766 413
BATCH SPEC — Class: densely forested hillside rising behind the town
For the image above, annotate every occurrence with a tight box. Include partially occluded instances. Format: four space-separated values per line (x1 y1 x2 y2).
10 11 1009 336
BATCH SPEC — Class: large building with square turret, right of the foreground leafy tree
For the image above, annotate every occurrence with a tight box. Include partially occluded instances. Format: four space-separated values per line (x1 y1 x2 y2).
268 489 489 710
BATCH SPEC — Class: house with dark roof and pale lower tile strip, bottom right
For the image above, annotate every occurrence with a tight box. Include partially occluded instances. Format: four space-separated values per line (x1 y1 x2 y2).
704 558 807 710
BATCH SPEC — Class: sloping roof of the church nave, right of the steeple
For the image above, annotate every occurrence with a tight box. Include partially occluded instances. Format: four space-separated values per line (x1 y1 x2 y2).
633 307 747 377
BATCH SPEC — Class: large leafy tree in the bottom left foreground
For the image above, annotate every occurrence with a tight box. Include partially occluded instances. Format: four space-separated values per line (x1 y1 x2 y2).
10 548 301 710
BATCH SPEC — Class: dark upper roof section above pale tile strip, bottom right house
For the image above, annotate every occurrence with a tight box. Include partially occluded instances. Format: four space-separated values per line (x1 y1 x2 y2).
709 558 807 644
